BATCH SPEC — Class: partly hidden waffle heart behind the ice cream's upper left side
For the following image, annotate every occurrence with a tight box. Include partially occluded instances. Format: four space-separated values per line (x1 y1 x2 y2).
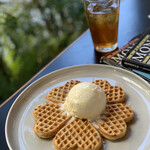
46 80 80 103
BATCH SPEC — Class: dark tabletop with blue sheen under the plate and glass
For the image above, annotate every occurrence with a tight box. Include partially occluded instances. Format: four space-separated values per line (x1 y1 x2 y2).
0 0 150 150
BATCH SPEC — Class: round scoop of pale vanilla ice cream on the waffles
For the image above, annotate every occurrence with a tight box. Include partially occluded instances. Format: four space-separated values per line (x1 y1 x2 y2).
62 82 106 121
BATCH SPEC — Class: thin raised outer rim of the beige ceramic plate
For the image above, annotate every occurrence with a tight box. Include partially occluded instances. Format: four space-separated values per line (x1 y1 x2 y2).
5 64 150 149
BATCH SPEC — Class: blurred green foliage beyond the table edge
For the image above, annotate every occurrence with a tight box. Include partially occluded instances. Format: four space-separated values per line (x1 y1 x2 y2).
0 0 87 102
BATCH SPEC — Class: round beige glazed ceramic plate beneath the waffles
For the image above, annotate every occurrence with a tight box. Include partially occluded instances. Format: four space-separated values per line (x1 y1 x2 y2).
5 65 150 150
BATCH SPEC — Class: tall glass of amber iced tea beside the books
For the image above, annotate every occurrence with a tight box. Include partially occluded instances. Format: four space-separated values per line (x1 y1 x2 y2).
83 0 120 53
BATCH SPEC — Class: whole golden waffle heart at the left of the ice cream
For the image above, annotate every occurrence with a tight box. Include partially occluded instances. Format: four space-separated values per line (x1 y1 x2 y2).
32 102 71 138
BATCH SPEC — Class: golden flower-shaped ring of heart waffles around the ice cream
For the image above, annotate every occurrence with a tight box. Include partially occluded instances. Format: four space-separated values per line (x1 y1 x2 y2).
33 80 134 150
